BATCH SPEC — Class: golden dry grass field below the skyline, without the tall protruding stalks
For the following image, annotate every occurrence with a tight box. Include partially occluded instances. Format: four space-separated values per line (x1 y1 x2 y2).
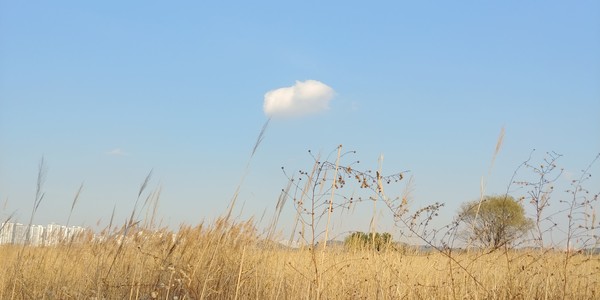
0 219 600 299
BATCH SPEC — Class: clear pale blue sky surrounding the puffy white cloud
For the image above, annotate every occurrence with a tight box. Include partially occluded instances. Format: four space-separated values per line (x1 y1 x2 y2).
0 1 600 241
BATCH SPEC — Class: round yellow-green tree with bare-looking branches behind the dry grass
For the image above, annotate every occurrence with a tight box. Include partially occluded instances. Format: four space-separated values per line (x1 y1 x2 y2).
459 196 533 249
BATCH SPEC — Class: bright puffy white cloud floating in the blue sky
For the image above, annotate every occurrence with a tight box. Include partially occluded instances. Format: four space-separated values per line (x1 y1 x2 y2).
263 80 335 117
